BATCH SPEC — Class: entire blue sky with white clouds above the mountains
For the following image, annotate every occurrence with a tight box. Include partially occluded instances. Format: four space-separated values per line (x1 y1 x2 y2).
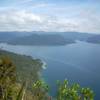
0 0 100 34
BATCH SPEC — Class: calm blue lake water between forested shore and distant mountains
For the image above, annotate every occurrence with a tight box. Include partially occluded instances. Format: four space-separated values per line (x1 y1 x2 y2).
0 41 100 100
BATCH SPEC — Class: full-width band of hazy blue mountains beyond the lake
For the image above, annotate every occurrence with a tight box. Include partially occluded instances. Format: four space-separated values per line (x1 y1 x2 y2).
0 31 100 45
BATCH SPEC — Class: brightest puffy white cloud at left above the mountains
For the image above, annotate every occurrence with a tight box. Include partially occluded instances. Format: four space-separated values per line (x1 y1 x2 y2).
0 10 41 31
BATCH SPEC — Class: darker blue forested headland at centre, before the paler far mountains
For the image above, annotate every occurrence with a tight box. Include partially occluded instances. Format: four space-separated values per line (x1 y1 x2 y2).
8 34 74 45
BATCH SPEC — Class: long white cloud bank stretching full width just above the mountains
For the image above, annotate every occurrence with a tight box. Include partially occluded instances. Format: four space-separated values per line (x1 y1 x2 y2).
0 10 100 33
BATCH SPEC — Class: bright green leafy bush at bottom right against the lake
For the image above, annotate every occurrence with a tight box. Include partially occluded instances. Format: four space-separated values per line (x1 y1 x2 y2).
57 80 94 100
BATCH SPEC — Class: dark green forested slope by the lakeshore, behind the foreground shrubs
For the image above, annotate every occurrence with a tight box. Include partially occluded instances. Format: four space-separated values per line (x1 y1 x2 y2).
0 50 42 82
